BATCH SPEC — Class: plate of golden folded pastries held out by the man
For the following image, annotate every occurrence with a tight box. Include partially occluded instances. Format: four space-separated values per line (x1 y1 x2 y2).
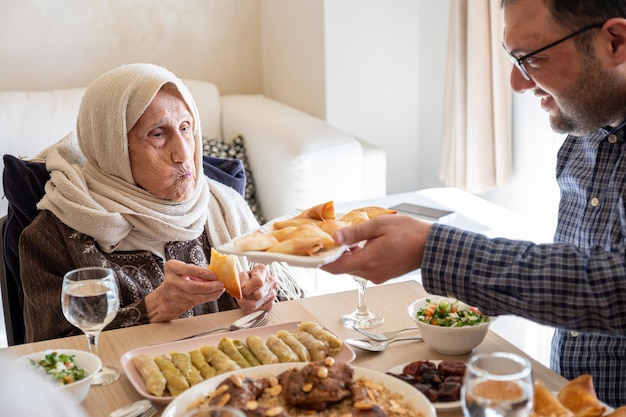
217 201 397 268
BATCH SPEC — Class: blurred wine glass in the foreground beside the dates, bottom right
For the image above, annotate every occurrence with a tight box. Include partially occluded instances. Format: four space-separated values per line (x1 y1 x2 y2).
461 352 535 417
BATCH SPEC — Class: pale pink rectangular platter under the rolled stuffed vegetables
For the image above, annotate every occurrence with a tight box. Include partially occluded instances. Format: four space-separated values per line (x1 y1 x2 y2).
120 321 356 404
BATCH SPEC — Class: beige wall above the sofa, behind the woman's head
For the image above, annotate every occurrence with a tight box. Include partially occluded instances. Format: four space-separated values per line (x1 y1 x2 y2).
0 0 262 93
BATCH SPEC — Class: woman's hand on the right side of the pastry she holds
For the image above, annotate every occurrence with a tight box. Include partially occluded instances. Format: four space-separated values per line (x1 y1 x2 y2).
237 264 278 313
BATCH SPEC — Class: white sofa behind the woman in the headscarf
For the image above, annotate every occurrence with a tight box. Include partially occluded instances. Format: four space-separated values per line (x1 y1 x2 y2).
0 80 386 219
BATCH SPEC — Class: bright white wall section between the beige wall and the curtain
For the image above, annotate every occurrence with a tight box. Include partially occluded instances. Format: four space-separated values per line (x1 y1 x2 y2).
324 0 420 193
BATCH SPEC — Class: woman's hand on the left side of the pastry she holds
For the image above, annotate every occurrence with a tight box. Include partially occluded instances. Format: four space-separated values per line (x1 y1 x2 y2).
145 259 224 323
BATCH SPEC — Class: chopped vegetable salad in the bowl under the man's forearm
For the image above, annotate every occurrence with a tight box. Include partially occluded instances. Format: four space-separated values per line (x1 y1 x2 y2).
416 298 489 327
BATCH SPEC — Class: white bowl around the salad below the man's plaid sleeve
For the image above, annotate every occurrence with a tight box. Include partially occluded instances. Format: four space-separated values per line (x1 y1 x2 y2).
408 296 495 355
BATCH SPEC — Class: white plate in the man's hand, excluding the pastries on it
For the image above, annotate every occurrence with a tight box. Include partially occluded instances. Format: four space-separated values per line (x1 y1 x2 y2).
215 212 348 268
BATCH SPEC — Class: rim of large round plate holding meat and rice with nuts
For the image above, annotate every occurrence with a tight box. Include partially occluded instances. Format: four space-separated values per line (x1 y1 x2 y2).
162 363 436 417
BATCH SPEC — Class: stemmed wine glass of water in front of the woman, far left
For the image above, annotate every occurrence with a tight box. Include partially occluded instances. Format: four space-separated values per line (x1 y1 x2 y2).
61 267 120 385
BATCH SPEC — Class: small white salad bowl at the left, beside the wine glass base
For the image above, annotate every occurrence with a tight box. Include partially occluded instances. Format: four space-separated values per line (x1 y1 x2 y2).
17 349 102 404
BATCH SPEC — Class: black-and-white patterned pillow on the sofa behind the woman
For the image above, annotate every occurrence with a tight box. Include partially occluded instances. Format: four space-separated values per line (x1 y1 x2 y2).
202 136 265 224
